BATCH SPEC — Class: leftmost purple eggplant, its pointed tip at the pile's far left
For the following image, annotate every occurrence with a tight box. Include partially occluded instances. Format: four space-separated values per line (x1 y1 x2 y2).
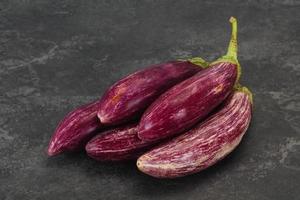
47 101 102 156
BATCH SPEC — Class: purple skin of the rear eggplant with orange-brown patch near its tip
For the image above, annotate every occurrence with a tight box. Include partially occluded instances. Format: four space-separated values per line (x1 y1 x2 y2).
98 61 202 124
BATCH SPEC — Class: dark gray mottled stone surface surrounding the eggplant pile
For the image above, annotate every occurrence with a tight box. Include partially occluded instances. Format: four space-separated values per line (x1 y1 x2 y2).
0 0 300 200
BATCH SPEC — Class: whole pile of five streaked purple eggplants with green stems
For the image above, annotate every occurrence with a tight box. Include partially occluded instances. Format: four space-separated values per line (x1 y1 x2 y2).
48 17 253 178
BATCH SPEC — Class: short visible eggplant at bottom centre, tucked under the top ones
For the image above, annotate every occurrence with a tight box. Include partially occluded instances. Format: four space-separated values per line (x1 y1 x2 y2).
85 124 153 161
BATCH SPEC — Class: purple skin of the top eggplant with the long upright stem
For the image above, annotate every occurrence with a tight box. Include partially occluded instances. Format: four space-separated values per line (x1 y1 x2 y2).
138 62 237 141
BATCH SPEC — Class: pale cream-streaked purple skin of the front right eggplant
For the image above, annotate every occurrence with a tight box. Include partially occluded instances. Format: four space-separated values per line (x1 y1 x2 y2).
137 92 252 178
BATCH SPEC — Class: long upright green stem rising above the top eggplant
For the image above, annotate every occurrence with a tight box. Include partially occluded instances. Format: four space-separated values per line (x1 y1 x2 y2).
226 17 238 59
